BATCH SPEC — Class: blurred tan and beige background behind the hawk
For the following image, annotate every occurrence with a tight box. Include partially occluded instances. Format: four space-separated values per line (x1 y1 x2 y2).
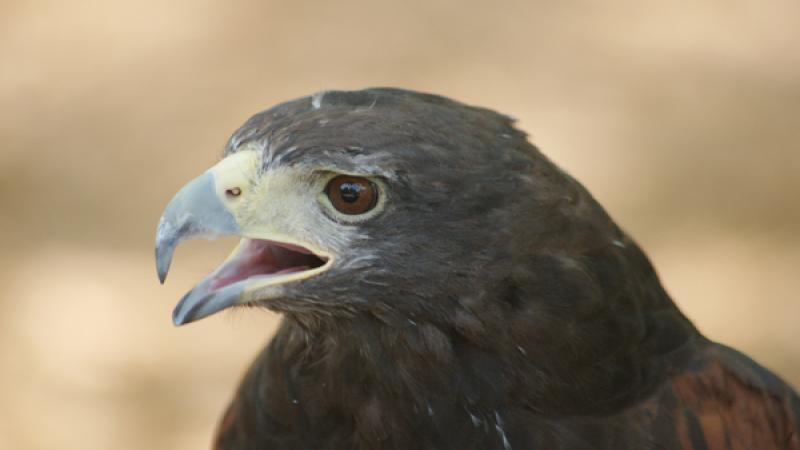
0 0 800 450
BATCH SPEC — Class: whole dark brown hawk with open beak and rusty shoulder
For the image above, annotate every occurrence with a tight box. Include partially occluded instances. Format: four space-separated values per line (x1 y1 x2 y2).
157 89 800 450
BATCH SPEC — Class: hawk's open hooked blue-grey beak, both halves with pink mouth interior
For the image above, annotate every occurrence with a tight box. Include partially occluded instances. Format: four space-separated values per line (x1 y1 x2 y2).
155 162 333 326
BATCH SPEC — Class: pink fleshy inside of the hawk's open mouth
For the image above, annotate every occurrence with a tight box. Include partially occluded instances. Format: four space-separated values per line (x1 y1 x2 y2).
210 239 324 290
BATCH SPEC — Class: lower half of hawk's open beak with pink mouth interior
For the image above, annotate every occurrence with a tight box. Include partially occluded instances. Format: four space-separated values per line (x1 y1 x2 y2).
172 238 333 326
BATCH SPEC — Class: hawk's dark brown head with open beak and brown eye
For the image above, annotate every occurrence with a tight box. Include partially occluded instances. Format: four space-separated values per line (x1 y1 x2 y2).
156 89 623 329
